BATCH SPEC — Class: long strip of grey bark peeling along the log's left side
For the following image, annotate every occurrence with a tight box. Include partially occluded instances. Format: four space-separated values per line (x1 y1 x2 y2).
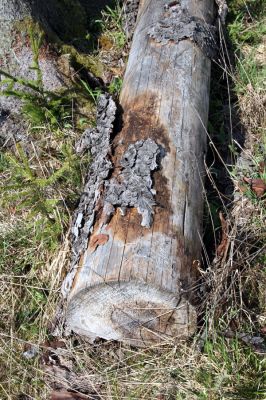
62 94 116 297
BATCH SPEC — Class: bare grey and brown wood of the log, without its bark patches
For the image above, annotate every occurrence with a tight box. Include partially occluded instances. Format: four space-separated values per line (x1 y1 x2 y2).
66 0 213 346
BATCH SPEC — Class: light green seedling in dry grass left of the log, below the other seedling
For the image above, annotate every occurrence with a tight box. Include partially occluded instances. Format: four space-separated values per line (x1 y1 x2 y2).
0 144 86 246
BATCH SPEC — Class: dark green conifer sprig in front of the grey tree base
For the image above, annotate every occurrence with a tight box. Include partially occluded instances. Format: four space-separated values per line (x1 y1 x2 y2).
0 28 71 127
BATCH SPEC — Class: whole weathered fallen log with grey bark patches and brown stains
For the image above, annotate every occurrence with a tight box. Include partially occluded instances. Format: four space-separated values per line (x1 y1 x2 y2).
63 0 215 346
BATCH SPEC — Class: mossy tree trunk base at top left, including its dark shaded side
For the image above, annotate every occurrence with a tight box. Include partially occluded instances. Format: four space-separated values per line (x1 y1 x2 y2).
0 0 111 146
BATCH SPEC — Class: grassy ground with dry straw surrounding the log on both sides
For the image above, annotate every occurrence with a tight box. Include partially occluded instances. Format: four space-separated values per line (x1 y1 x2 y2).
0 0 266 400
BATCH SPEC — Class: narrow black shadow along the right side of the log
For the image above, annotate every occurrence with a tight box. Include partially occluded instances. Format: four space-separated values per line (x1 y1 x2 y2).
202 32 246 268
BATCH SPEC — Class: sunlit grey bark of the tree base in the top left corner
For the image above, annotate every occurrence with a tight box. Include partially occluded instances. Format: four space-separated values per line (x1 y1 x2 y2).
0 0 63 147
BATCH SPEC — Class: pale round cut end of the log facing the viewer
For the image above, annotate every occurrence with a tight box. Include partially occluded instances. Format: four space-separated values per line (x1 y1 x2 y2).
66 281 196 347
